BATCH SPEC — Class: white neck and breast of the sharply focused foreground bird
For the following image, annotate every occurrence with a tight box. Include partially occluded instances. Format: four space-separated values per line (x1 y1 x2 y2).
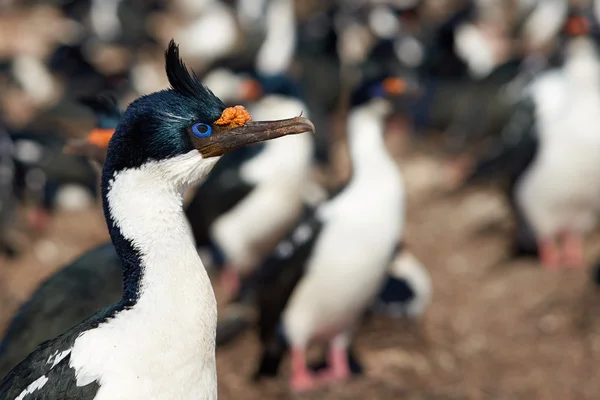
70 150 217 400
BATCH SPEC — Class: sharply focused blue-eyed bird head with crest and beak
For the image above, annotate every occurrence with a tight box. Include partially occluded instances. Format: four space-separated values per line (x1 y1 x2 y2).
104 41 314 182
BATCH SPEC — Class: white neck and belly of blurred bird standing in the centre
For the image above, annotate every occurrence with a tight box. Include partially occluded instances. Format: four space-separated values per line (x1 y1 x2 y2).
283 101 404 360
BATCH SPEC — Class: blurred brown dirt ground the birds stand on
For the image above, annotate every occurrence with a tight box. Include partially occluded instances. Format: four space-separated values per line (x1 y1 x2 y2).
0 148 600 400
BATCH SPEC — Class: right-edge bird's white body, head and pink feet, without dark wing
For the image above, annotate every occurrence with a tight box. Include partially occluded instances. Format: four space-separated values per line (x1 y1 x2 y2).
515 10 600 268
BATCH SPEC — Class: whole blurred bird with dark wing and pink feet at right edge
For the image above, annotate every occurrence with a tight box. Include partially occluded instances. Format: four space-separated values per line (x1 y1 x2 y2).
460 4 600 268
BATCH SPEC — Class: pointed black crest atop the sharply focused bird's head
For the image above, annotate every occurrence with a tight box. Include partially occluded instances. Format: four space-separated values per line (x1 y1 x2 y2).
165 39 225 109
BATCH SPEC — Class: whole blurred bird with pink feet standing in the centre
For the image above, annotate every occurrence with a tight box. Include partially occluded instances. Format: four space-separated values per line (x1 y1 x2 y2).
255 71 404 391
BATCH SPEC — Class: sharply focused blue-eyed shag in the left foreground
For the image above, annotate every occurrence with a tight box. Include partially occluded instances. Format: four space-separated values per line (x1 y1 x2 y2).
0 42 313 400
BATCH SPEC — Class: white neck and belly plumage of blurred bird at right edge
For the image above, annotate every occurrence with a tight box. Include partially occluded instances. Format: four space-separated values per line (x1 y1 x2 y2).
517 38 600 241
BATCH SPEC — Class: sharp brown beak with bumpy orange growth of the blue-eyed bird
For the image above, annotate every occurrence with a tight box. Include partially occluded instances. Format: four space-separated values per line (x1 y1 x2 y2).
190 106 315 158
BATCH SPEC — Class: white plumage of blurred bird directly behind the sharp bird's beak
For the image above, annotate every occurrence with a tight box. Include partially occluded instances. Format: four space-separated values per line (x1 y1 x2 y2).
211 95 314 273
